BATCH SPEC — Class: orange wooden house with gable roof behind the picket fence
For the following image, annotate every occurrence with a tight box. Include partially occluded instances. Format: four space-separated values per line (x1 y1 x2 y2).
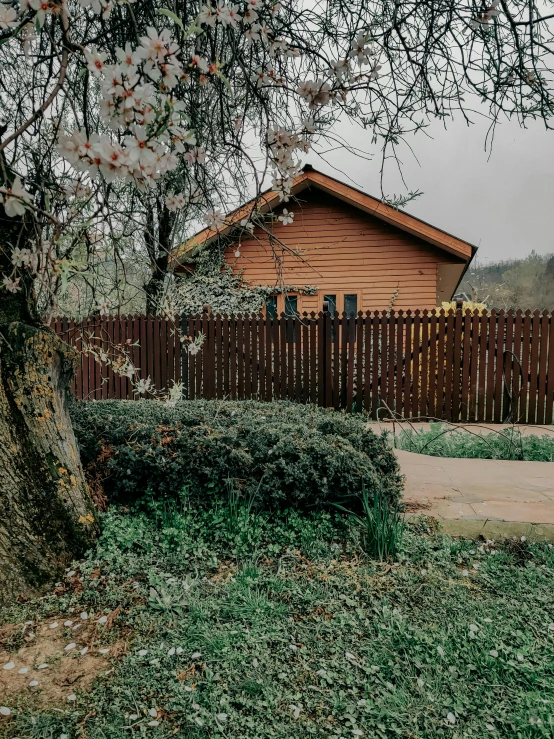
174 165 476 315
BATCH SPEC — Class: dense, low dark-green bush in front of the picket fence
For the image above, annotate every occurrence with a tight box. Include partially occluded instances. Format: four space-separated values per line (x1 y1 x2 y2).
72 400 402 508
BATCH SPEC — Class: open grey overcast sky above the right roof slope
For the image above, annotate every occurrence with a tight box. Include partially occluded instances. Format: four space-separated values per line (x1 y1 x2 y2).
307 115 554 262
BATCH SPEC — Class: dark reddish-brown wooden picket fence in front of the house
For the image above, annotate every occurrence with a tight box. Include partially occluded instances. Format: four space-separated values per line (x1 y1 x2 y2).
53 310 554 424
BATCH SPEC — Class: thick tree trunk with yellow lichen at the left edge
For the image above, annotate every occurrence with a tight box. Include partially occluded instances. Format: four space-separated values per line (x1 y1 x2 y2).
0 321 98 604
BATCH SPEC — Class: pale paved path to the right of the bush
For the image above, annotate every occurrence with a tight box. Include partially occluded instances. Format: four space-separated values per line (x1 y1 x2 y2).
395 449 554 541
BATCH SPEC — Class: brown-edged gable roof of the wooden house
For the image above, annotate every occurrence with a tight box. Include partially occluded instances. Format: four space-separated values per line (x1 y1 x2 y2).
172 164 477 267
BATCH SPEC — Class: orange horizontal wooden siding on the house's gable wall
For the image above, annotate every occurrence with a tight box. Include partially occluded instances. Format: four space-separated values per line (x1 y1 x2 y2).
225 189 463 311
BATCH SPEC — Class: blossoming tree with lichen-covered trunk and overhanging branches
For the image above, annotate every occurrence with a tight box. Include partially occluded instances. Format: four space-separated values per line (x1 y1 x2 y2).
0 0 553 598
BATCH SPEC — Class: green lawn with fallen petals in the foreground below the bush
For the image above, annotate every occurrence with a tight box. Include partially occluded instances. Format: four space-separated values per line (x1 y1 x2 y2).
0 494 554 739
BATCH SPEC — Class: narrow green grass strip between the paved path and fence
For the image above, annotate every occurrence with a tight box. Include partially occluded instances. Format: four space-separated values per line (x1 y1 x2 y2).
395 423 554 462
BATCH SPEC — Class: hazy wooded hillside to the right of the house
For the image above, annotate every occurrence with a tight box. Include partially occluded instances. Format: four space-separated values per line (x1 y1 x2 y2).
457 252 554 310
